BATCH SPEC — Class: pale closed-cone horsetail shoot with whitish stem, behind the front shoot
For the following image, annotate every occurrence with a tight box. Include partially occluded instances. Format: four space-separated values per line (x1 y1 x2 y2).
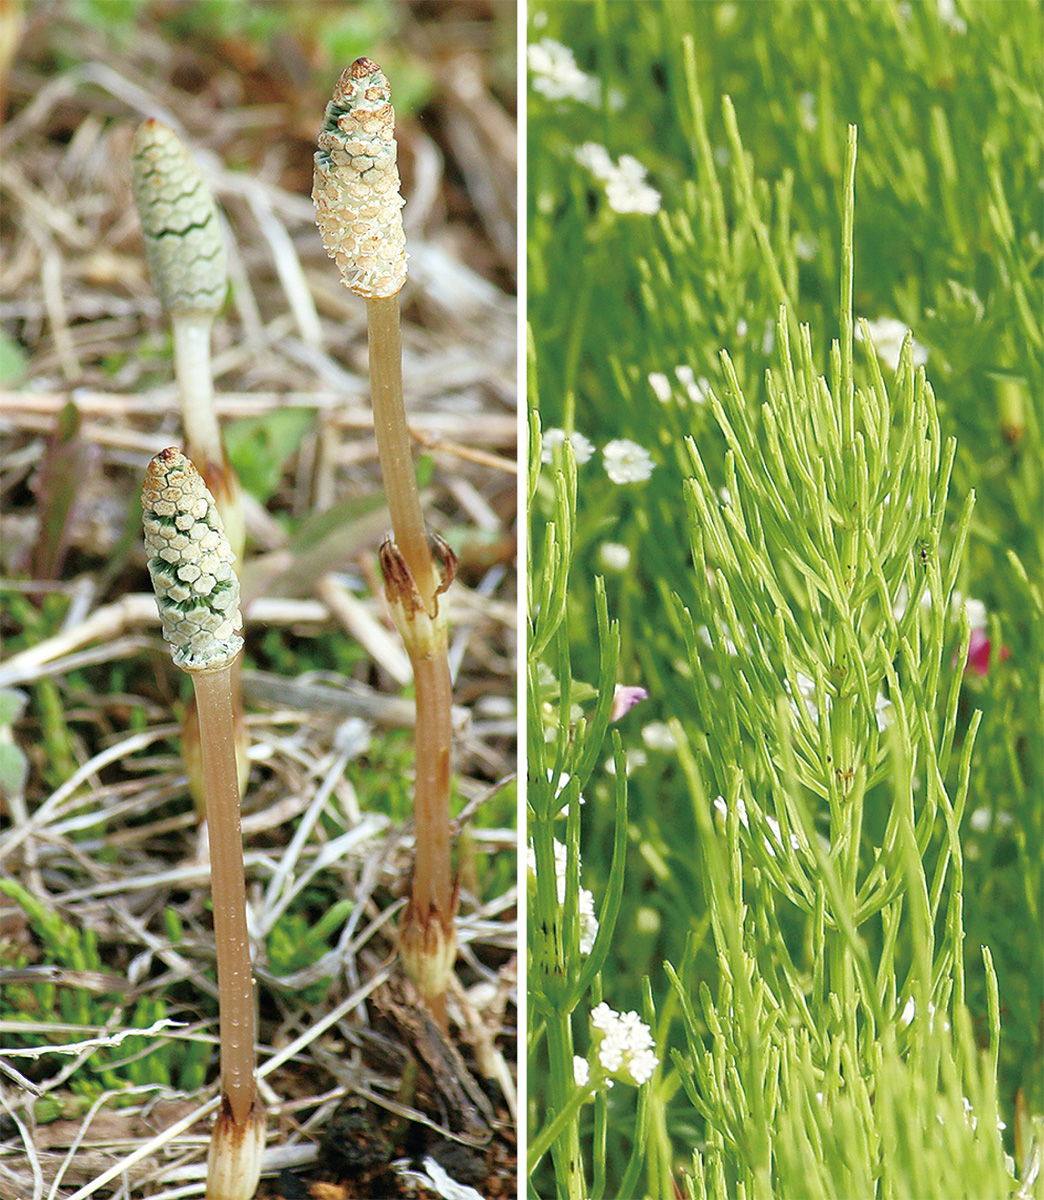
132 120 248 816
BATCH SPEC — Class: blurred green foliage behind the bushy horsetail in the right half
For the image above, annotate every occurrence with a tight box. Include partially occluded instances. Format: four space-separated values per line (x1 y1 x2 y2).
527 0 1044 1177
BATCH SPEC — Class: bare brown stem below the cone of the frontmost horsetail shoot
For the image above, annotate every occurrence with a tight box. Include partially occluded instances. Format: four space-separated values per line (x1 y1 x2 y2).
191 664 256 1126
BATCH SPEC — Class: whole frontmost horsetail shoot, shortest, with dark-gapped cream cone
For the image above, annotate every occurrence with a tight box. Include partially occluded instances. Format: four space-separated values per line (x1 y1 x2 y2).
142 449 265 1200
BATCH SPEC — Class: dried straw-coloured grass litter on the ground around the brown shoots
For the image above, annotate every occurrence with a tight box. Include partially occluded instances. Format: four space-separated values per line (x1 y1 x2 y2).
0 4 516 1198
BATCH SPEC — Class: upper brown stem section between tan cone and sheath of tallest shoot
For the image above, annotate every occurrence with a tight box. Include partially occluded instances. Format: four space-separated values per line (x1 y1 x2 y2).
366 294 438 613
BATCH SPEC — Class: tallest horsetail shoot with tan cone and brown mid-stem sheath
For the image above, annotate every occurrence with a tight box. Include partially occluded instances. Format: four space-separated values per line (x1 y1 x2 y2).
312 59 457 1027
